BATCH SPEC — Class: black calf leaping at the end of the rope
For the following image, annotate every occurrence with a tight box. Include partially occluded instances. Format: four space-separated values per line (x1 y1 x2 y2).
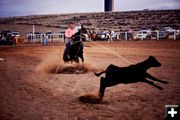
95 56 168 98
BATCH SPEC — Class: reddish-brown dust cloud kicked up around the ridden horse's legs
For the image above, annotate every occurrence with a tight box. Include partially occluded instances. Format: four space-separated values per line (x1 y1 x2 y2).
35 51 103 74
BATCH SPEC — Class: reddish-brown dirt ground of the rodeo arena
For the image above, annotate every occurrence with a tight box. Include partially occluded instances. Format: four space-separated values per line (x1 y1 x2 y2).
0 40 180 120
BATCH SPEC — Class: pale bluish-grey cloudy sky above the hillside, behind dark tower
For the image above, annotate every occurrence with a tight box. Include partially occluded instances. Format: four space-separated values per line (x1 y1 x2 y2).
0 0 180 17
